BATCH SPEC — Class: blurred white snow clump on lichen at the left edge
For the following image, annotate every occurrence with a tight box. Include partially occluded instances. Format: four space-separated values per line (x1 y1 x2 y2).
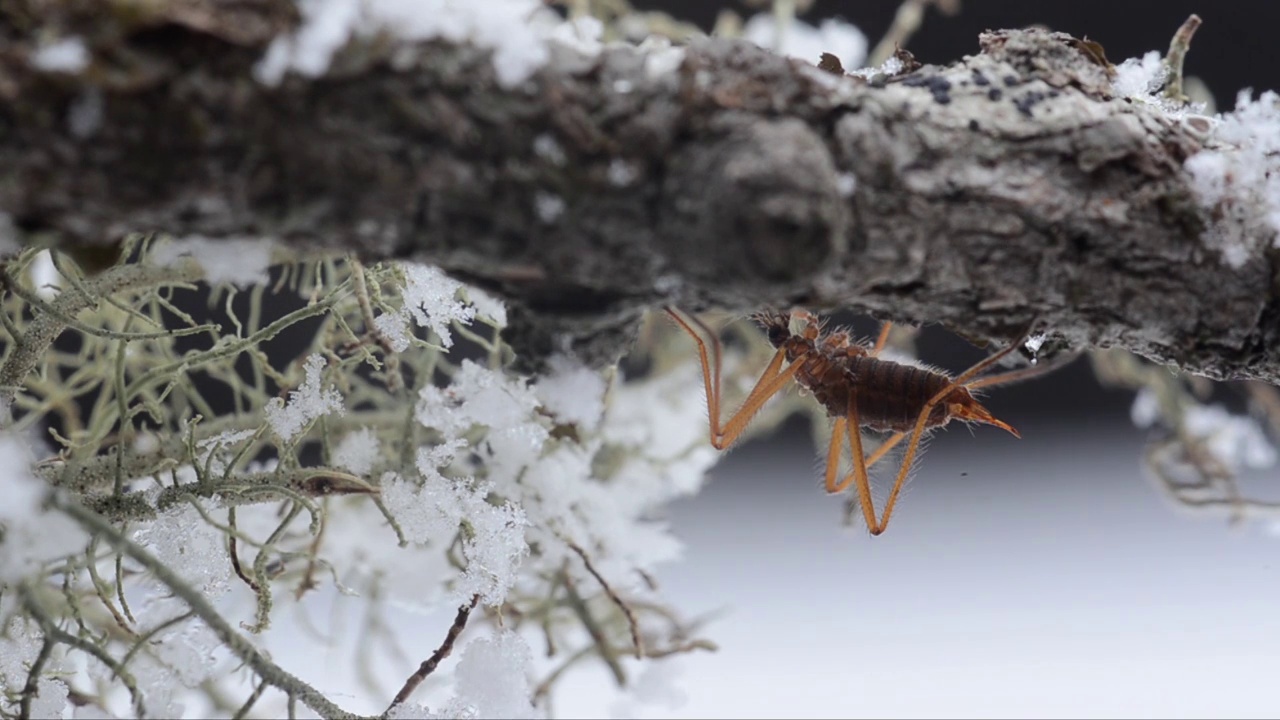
0 434 88 587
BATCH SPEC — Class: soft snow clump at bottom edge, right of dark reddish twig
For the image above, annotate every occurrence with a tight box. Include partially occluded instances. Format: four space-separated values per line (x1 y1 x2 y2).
447 630 538 719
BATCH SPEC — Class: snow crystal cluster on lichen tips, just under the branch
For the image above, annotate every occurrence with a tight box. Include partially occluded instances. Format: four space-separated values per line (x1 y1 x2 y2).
374 263 481 352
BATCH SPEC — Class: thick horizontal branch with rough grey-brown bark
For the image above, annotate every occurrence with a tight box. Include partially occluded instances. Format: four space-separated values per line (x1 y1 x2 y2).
0 0 1280 382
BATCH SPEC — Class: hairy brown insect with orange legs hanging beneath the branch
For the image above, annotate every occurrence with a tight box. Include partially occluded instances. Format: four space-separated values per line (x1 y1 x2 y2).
666 307 1054 536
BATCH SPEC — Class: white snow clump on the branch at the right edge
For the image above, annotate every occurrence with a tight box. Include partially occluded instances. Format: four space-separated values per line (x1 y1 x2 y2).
1183 90 1280 268
